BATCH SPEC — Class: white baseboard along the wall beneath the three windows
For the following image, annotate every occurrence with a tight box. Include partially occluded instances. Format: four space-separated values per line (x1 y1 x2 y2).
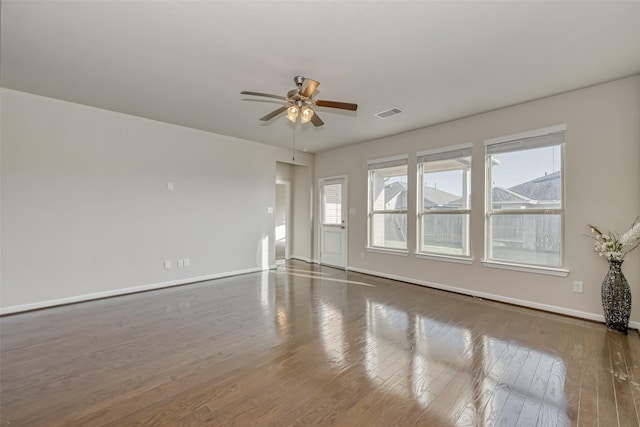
347 267 640 329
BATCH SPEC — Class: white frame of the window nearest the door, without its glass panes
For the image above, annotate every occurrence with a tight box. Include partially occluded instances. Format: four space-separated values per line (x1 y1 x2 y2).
367 154 409 254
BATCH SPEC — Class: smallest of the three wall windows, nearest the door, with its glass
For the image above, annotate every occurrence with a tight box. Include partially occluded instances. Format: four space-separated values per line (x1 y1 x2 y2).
369 156 407 250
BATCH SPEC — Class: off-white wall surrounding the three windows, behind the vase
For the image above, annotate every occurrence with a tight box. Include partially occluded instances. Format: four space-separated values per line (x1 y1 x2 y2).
315 76 640 327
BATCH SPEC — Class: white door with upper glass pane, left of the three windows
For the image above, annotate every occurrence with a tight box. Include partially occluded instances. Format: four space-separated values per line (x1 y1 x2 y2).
319 177 347 268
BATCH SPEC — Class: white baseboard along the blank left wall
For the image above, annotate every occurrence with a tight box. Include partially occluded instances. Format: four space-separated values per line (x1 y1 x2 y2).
0 264 276 316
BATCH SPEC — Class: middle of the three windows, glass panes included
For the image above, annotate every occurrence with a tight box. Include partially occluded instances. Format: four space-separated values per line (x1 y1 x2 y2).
417 144 471 257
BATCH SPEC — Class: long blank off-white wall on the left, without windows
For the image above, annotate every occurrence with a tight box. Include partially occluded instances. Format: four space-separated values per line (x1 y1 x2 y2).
0 89 313 313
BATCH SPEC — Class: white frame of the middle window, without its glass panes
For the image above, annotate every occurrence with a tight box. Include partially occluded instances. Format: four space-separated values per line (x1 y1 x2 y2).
416 143 473 263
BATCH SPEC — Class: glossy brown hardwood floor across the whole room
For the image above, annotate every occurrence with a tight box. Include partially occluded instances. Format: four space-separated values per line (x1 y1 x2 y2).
0 262 640 427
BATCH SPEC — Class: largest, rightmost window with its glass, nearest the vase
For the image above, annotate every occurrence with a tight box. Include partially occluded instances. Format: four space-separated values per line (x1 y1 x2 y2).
485 125 566 267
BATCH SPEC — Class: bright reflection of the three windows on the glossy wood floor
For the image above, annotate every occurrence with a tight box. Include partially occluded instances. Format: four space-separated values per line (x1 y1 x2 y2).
365 301 570 425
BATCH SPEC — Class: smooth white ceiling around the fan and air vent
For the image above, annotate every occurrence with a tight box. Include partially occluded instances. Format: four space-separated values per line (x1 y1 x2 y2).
0 0 640 152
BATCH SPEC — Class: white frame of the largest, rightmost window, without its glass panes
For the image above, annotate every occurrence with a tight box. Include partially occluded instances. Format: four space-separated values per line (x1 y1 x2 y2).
482 124 569 277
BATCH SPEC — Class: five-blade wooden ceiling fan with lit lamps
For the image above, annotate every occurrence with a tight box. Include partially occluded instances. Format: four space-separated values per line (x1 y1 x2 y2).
240 76 358 126
